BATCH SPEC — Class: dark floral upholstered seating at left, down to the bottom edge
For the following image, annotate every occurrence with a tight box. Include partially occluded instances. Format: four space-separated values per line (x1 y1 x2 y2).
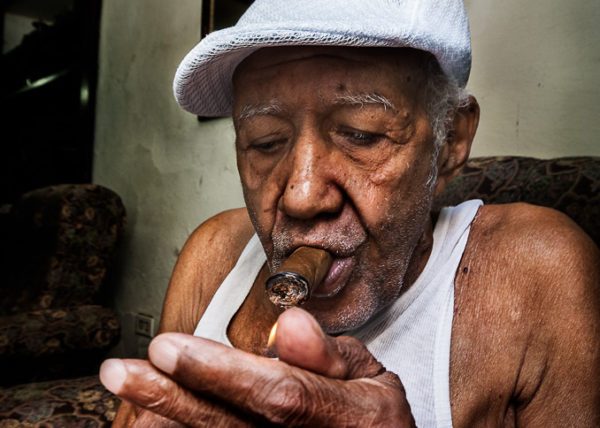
0 184 125 426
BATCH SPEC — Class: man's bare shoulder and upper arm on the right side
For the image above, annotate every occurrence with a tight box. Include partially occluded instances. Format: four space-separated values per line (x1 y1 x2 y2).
451 203 600 426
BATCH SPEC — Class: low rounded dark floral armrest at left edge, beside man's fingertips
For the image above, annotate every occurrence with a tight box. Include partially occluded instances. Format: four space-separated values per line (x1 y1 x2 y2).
0 305 120 361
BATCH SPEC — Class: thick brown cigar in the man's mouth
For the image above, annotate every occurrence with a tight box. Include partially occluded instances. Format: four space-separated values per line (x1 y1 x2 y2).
266 247 333 308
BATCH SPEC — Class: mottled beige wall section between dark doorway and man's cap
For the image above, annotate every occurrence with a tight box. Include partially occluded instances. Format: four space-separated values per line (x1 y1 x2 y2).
94 0 243 355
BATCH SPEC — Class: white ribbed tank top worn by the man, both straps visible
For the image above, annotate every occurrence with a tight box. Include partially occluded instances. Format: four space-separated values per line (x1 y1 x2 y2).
194 200 482 427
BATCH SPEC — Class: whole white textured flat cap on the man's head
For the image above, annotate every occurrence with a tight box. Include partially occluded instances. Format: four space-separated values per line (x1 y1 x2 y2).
173 0 471 117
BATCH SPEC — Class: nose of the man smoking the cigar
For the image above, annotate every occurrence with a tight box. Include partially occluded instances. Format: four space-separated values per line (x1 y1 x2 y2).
279 130 344 220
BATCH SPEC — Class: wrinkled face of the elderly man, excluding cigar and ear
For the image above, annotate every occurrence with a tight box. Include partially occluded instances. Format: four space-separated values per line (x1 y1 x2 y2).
233 47 434 333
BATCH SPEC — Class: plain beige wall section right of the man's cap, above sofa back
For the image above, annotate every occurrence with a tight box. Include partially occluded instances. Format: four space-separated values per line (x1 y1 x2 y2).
465 0 600 157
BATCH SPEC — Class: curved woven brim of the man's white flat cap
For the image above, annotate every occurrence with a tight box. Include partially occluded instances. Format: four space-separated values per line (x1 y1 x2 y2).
173 23 471 117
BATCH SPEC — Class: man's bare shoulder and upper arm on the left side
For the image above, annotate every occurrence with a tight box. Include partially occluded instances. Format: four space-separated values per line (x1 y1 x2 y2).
160 208 254 333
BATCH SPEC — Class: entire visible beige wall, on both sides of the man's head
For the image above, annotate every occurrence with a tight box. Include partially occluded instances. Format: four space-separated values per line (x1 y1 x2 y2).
94 0 600 355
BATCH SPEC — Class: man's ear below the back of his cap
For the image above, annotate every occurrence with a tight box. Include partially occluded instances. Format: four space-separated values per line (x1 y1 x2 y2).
435 95 479 196
